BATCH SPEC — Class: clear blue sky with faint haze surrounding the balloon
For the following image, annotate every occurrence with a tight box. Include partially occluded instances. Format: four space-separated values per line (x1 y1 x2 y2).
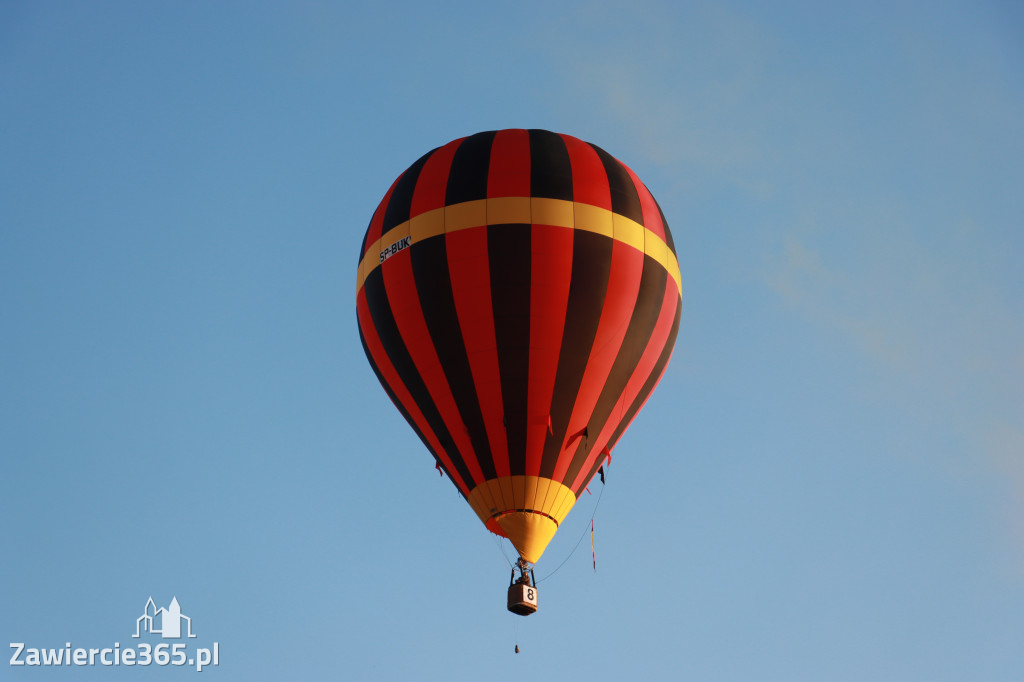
0 0 1024 682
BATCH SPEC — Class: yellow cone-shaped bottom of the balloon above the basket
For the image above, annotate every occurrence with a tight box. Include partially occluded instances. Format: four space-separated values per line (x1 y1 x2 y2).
469 476 575 563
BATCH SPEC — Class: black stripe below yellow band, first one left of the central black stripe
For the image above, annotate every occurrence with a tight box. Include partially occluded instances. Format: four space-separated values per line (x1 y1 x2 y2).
410 235 495 477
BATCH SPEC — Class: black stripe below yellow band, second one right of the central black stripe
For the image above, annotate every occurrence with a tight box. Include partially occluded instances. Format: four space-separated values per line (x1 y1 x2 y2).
565 256 669 481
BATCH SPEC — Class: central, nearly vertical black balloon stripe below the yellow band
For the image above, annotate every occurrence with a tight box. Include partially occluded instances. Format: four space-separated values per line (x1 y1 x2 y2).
487 224 531 475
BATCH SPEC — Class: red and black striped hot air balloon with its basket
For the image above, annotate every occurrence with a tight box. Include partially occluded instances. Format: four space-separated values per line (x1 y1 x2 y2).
356 129 682 614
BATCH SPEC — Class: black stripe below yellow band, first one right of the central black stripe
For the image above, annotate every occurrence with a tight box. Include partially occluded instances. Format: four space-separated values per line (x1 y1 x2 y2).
541 229 612 478
